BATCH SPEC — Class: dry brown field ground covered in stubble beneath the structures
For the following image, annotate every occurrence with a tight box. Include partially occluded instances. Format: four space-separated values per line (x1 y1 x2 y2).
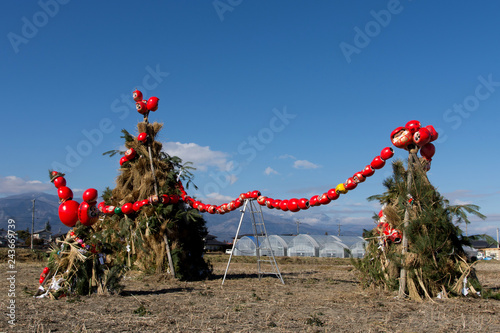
0 250 500 332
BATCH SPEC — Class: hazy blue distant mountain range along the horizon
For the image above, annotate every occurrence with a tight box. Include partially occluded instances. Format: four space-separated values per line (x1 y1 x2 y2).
0 192 361 242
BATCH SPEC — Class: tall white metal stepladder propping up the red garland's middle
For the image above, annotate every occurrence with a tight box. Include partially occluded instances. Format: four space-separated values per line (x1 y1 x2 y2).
222 199 285 285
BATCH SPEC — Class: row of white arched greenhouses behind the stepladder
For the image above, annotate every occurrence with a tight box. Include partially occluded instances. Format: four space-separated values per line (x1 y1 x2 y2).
233 234 366 258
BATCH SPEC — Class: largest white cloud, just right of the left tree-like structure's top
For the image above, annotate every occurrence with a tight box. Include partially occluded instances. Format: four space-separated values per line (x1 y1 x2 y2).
163 142 232 171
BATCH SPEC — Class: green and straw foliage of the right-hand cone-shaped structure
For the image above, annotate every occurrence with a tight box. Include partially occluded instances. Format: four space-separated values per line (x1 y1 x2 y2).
355 160 484 297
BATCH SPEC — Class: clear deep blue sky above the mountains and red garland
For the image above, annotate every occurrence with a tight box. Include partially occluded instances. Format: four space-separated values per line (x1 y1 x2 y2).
0 0 500 235
